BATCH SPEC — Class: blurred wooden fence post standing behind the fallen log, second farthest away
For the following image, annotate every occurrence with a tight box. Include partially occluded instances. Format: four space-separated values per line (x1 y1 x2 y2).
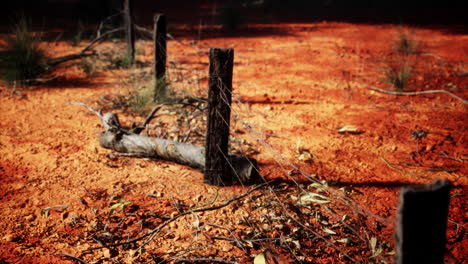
153 14 167 102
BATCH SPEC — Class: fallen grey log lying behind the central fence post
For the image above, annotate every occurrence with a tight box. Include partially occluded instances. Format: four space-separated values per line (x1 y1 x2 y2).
70 103 260 185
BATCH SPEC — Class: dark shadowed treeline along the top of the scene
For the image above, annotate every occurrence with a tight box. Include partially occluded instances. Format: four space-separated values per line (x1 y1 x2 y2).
0 0 468 27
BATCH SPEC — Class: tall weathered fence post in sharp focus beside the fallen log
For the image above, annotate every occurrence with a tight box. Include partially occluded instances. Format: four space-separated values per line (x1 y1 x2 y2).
204 48 234 186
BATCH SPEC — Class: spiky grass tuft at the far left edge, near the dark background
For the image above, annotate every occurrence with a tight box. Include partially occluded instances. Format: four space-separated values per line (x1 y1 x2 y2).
0 17 48 85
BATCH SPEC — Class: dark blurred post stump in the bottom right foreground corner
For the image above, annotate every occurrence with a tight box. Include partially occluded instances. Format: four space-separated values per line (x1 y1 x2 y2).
395 180 450 264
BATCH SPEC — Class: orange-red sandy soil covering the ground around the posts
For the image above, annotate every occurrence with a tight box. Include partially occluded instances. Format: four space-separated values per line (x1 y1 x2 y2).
0 22 468 263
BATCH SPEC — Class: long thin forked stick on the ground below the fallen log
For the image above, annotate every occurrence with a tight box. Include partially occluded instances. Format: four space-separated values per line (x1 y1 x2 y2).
85 182 271 252
